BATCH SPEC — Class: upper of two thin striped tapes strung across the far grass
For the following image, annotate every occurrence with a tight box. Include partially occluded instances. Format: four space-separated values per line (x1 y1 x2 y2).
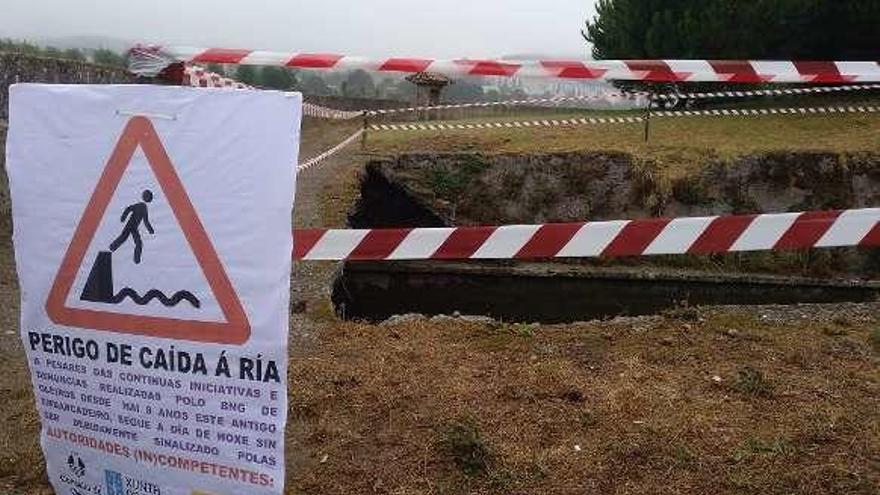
366 84 880 116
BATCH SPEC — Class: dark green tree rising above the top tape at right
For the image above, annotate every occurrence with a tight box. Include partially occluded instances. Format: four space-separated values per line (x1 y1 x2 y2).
582 0 880 60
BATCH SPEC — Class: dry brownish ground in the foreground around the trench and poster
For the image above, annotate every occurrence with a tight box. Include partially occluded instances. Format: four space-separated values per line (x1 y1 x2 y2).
0 114 880 495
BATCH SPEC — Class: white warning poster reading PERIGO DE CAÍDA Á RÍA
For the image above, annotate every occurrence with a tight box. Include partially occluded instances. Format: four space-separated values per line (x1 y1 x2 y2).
7 84 301 495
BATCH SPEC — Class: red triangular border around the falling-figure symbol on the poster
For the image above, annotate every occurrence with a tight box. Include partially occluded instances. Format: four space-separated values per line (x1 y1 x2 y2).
46 117 250 344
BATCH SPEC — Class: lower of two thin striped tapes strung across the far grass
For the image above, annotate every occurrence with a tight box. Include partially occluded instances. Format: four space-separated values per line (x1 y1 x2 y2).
369 106 880 131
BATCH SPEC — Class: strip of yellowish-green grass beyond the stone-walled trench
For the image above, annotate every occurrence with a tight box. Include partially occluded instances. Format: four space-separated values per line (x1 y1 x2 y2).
368 110 880 156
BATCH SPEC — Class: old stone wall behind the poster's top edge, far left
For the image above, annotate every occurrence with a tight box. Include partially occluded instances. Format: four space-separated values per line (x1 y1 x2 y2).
0 52 134 120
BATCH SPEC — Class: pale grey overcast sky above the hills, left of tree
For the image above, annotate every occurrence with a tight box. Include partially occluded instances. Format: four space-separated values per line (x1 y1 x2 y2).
0 0 596 58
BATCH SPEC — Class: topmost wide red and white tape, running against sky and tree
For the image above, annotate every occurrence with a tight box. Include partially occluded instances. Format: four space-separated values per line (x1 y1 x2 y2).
153 47 880 84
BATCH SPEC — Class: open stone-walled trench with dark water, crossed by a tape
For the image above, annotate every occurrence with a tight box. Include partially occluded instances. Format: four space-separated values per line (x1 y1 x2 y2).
332 154 880 323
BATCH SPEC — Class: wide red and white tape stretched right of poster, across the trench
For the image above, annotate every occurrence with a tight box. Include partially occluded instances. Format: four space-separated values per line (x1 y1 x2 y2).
294 208 880 260
